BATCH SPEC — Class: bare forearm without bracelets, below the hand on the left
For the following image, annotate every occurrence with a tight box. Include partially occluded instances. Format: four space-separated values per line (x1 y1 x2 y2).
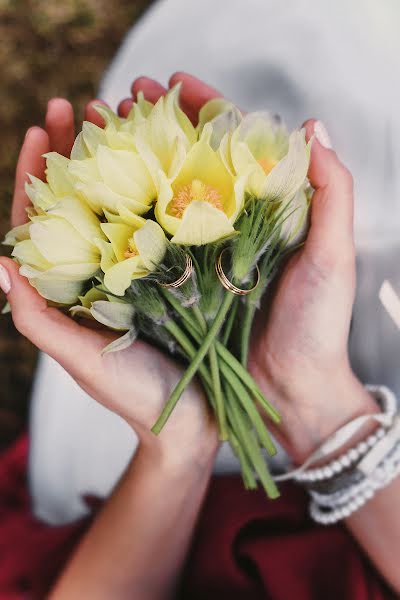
51 444 216 600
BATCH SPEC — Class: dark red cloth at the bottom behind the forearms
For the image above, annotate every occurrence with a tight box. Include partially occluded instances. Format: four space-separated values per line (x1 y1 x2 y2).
0 437 394 600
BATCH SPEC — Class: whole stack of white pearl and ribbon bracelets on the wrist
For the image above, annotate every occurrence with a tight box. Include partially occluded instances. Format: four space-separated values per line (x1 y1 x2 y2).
275 386 400 525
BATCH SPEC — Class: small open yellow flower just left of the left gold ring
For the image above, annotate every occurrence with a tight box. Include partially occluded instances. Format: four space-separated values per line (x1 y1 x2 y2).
99 214 167 296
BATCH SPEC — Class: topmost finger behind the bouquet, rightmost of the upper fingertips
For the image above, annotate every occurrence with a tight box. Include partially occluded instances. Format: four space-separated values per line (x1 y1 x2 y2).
169 72 222 124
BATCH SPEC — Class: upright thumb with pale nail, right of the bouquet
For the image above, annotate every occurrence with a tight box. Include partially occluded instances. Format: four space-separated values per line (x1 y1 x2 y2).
304 120 354 260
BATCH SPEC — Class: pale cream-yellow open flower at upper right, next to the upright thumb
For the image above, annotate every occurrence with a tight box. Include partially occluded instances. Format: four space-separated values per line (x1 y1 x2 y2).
221 113 311 203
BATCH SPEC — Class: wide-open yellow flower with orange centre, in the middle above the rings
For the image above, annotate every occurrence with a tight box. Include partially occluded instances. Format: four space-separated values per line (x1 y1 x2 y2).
155 124 245 246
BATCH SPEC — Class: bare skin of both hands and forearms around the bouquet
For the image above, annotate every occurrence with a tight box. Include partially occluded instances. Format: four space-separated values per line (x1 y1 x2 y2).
0 73 400 599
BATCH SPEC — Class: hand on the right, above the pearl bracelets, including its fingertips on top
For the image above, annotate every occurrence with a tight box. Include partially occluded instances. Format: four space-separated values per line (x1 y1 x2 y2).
126 73 376 462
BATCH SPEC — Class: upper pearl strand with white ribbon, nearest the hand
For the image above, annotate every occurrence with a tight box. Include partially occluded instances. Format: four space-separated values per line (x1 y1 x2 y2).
274 385 397 484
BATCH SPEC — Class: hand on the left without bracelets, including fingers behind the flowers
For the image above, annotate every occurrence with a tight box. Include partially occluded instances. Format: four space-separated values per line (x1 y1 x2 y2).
0 99 217 464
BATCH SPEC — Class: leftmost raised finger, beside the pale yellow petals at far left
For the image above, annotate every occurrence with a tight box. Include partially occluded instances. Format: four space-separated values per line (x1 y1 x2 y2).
11 127 50 227
